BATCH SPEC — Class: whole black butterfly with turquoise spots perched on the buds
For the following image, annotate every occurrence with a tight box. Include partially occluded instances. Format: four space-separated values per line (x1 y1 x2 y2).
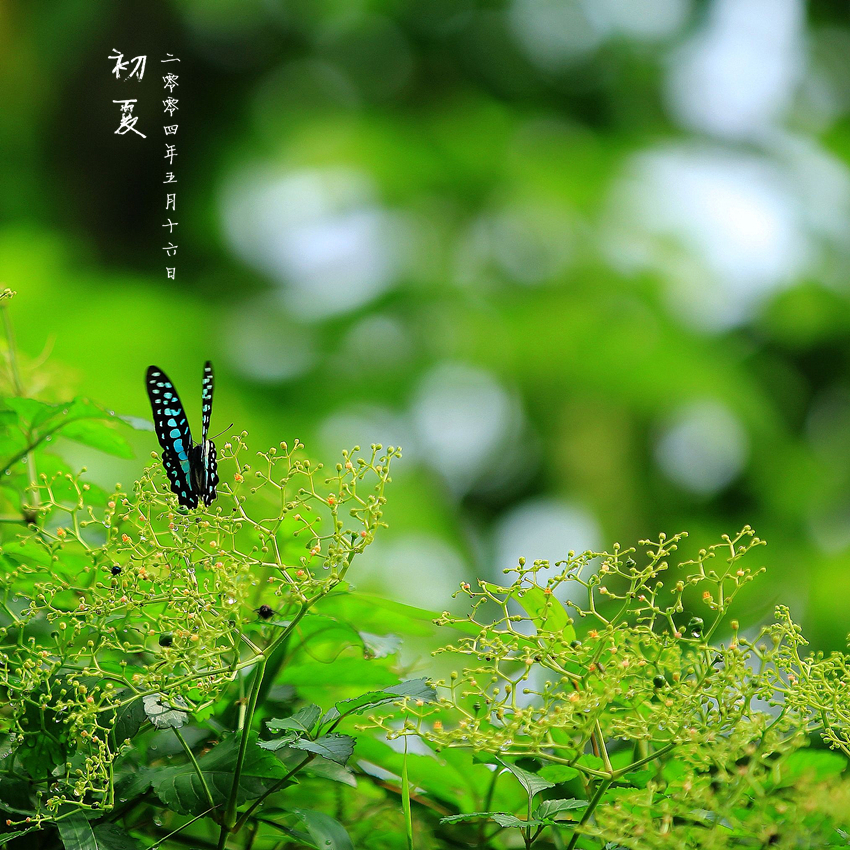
147 360 218 508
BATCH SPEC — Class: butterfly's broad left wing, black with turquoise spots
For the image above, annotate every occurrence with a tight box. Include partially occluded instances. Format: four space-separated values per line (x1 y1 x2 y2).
147 366 198 508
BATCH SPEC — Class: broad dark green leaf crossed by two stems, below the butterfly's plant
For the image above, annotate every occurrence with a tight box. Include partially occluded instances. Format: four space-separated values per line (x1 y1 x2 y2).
151 732 287 815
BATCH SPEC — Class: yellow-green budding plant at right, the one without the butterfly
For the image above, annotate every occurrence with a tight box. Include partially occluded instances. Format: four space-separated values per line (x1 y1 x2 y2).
375 528 850 849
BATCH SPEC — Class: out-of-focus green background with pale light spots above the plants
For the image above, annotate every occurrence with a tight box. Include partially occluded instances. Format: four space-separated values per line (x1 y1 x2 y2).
0 0 850 648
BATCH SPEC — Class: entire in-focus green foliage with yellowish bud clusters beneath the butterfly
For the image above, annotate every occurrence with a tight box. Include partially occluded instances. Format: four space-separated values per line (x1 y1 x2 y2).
0 294 850 850
